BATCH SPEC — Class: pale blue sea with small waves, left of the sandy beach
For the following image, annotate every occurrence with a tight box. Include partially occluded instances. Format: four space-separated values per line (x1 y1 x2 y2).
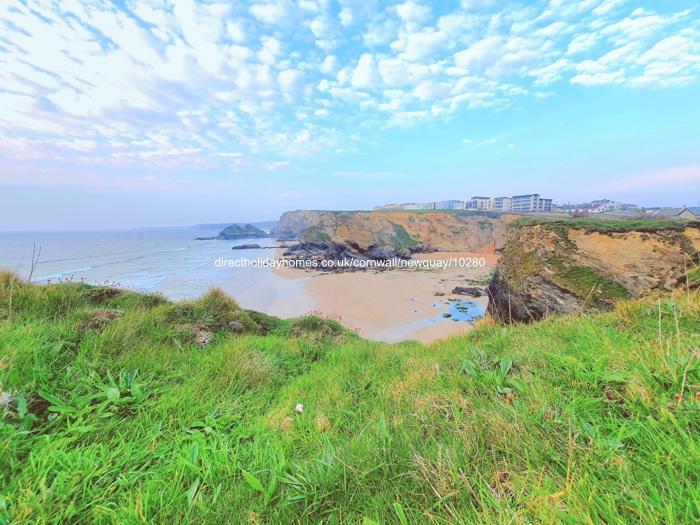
0 228 290 306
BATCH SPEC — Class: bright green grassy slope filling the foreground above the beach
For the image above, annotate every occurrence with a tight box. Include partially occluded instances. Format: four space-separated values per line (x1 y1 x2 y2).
0 274 700 524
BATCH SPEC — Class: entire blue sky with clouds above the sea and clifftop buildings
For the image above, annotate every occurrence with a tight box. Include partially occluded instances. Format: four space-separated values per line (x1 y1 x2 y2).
0 0 700 231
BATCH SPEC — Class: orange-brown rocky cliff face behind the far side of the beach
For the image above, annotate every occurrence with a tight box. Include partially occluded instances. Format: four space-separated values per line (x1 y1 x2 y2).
278 212 515 259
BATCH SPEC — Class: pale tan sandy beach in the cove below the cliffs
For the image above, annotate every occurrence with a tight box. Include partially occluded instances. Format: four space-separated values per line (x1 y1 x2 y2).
268 252 498 343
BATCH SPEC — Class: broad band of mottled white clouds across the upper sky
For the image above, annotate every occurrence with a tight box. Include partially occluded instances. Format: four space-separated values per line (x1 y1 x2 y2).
0 0 700 177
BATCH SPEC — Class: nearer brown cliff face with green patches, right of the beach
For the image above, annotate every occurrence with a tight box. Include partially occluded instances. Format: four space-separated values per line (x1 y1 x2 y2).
489 221 700 323
